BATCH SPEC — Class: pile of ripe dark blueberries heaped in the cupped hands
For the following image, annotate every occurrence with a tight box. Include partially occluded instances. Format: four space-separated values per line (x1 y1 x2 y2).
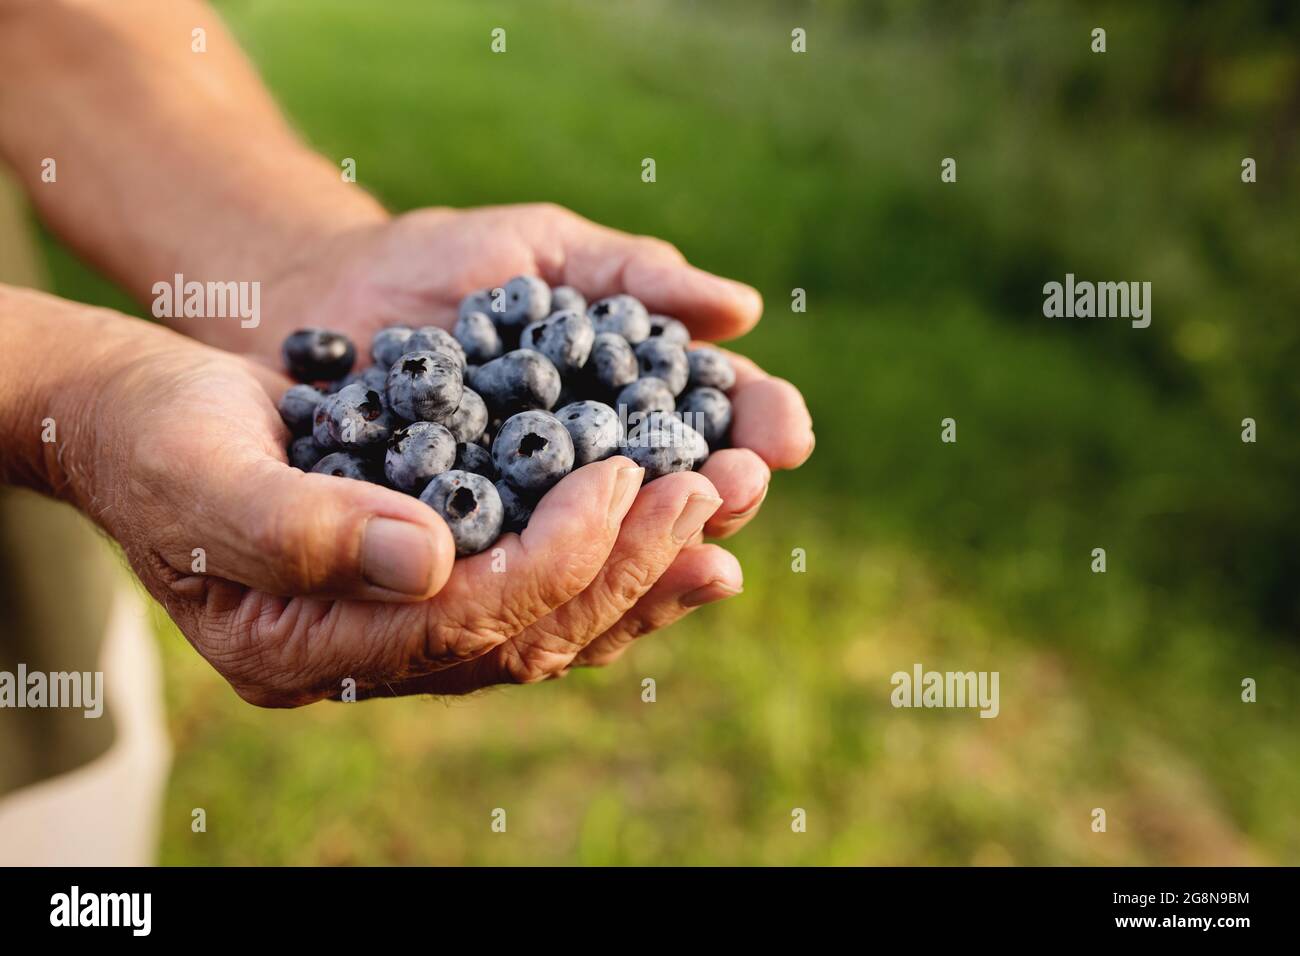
280 276 736 554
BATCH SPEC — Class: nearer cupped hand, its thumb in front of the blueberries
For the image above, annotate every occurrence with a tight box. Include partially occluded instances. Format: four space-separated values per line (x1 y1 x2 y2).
53 313 740 706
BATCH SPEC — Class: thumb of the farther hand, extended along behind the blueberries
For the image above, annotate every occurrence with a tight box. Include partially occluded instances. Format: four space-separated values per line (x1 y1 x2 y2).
560 216 763 339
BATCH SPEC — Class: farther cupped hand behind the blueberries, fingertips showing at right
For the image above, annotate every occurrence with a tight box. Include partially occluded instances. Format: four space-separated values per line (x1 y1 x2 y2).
263 204 814 663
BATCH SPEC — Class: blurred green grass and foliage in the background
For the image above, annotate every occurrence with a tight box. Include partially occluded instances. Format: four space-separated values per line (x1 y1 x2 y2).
35 0 1300 864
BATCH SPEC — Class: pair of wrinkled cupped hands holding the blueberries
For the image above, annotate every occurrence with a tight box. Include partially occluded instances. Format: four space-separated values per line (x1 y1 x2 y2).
62 206 813 706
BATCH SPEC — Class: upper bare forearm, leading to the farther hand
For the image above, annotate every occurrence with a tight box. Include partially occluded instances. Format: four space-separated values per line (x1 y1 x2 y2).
0 0 385 349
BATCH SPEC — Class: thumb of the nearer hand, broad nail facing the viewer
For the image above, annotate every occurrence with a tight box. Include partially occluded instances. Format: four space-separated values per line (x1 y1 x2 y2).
176 447 456 601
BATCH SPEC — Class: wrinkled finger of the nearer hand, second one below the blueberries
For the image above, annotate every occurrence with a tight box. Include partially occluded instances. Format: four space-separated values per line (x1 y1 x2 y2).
371 472 720 693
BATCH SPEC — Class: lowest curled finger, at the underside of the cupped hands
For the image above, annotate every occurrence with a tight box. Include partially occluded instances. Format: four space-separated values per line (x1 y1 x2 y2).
573 545 745 667
